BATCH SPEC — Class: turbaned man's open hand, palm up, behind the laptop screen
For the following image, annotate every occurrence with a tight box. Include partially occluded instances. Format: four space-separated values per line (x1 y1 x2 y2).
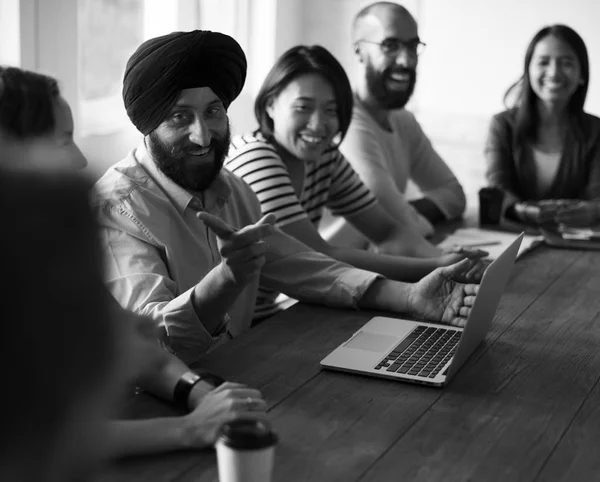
410 259 479 326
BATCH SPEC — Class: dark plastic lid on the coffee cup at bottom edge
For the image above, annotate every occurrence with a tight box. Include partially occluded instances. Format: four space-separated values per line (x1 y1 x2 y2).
218 419 277 450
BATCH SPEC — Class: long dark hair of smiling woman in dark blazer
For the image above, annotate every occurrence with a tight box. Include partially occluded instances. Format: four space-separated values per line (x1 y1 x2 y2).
504 25 590 141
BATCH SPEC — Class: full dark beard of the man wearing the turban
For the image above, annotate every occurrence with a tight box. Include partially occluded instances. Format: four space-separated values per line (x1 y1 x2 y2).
147 126 231 192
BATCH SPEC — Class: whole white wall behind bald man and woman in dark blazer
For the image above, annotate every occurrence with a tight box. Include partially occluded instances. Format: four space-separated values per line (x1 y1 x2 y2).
278 0 600 127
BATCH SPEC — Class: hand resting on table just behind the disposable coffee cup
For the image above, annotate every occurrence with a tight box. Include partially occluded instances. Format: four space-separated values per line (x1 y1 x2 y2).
184 382 267 448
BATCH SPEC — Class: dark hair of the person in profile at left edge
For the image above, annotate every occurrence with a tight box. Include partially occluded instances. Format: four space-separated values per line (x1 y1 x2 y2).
0 66 60 140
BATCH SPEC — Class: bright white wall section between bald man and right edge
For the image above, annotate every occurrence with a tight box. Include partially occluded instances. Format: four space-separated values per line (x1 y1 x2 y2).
418 0 600 130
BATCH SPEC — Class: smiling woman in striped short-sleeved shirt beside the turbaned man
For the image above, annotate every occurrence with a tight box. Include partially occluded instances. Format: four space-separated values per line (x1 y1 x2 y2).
225 45 485 314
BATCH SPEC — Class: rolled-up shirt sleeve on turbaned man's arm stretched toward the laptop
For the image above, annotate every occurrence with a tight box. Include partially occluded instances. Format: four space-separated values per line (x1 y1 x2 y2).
261 229 381 308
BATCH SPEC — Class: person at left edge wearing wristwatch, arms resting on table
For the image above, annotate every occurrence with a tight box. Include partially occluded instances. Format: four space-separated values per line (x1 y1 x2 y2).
0 67 266 456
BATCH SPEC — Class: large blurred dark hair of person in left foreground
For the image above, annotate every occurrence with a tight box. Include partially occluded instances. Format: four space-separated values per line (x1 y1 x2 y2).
0 168 116 457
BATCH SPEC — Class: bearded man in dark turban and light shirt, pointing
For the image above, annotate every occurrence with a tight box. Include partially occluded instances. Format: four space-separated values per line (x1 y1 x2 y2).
93 30 477 363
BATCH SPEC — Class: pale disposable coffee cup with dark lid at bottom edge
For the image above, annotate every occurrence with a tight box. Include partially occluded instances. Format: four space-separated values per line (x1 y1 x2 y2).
215 420 277 482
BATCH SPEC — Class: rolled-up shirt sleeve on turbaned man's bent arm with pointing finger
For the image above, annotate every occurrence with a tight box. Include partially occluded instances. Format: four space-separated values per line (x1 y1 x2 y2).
100 206 223 360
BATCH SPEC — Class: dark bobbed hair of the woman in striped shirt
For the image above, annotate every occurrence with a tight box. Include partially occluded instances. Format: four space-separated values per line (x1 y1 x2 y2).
254 45 353 141
